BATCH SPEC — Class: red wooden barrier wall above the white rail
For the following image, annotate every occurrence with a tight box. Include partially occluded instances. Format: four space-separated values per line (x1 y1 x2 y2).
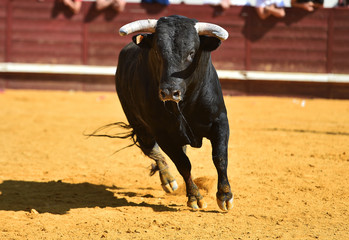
0 0 349 73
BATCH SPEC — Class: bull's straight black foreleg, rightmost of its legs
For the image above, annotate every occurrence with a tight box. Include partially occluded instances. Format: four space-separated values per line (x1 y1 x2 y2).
211 115 233 211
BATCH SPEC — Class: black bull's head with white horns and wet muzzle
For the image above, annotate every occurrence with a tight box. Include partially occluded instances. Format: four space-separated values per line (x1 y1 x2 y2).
119 16 228 103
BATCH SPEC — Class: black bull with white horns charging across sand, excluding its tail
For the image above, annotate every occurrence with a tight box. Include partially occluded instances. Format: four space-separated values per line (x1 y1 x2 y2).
115 16 233 210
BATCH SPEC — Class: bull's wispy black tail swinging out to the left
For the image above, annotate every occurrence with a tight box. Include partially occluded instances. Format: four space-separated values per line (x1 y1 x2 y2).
84 122 140 153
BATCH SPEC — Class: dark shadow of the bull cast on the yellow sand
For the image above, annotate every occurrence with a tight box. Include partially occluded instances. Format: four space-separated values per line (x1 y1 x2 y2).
0 180 177 214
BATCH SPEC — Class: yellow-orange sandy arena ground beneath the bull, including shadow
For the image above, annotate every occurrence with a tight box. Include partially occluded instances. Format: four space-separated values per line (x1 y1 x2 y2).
0 90 349 240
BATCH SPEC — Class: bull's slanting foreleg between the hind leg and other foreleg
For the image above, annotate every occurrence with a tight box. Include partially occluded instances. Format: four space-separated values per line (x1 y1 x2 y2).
163 144 207 210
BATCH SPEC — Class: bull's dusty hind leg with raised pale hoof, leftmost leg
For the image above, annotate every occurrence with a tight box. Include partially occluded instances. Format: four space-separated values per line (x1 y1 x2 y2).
148 143 178 193
